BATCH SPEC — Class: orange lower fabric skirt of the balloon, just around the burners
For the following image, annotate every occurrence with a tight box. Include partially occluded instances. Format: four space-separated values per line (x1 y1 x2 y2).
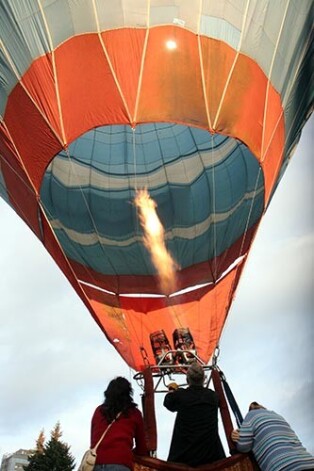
84 265 242 371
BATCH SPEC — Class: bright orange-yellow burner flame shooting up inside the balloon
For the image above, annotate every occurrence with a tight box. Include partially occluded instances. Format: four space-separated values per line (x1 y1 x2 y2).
134 189 178 294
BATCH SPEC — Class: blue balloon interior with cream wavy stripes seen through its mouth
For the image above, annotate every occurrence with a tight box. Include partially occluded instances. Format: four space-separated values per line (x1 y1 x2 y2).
40 123 264 297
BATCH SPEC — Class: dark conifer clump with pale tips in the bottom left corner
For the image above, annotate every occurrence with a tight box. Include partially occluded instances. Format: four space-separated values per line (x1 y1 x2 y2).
24 422 75 471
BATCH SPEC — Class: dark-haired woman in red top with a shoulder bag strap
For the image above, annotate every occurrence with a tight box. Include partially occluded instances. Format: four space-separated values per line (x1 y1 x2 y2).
91 376 148 471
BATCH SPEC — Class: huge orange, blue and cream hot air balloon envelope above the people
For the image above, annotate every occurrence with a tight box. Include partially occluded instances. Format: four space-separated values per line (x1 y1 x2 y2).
0 0 313 469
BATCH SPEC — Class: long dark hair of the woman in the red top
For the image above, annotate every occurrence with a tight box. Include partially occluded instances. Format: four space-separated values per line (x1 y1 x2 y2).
101 376 137 422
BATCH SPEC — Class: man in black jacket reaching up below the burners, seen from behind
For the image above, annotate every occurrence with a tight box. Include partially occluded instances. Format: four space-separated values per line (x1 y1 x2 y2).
164 361 226 466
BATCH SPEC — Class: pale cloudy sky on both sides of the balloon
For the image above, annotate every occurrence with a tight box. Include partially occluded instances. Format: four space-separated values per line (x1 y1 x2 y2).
0 116 314 464
